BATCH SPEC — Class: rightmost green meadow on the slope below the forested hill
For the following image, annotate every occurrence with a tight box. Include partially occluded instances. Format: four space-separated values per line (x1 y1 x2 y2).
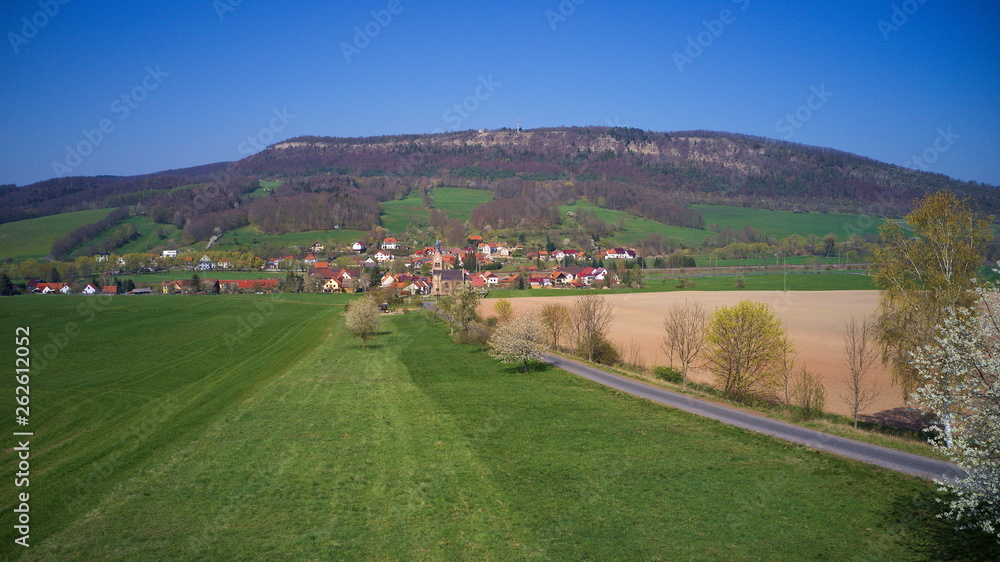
691 205 883 240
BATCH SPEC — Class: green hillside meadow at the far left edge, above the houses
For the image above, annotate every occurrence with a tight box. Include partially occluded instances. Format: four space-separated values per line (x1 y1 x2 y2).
0 209 111 259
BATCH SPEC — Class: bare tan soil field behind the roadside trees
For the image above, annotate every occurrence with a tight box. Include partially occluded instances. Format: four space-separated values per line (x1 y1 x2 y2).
480 291 905 416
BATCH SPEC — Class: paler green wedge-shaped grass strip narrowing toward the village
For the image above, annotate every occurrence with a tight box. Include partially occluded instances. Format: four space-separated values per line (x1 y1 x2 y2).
25 312 524 559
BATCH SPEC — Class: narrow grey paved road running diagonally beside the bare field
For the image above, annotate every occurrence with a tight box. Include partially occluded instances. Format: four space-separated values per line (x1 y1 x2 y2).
423 302 965 480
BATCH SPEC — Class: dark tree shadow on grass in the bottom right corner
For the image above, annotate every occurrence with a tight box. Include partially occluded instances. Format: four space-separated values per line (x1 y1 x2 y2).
886 490 1000 561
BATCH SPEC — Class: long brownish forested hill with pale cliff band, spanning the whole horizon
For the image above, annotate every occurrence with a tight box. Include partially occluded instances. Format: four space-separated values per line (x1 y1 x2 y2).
0 127 1000 244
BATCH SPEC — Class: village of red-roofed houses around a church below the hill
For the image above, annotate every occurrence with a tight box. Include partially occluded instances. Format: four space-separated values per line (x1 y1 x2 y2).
25 235 639 297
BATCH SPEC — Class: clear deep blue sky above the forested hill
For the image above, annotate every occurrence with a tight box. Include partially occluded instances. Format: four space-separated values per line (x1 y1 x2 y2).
0 0 1000 185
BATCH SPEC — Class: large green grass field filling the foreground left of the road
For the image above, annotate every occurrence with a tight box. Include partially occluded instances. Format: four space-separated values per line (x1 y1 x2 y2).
0 296 997 560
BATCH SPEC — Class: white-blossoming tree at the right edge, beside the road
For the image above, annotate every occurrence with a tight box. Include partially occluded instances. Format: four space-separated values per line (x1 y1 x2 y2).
912 288 1000 539
